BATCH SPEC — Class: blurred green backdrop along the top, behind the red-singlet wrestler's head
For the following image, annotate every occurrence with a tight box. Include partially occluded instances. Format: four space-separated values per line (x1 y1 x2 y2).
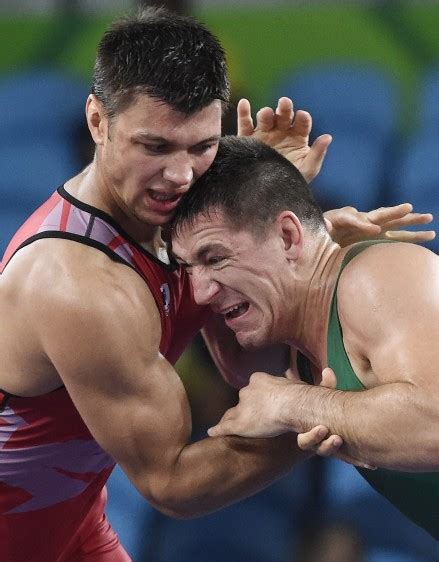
0 2 439 130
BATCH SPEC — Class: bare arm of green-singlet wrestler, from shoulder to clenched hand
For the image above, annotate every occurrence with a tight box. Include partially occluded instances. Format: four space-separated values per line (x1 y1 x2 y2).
211 244 439 471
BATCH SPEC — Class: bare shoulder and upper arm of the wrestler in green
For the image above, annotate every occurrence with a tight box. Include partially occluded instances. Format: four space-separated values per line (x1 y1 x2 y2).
339 244 439 388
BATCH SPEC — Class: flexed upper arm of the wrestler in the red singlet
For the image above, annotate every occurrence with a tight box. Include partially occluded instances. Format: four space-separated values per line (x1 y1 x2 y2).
38 270 191 490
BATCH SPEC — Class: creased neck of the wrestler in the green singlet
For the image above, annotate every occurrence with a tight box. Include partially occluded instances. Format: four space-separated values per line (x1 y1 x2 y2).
287 231 346 369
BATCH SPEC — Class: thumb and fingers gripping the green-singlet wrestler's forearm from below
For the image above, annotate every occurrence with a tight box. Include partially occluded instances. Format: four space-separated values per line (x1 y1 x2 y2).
297 368 376 470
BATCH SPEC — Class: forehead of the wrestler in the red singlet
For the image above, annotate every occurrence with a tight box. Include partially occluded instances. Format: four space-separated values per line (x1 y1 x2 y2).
116 94 221 140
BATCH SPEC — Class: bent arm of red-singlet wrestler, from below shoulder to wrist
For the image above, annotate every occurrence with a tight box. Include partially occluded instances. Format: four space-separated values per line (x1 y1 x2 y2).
35 245 308 517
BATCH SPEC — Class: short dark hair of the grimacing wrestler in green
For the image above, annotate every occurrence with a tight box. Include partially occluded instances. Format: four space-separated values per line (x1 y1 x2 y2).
170 136 325 235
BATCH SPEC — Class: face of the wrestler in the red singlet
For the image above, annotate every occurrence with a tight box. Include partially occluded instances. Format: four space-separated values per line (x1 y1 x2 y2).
98 95 221 226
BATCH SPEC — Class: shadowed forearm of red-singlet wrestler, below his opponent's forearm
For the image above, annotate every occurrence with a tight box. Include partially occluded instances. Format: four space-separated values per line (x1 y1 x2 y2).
148 433 309 518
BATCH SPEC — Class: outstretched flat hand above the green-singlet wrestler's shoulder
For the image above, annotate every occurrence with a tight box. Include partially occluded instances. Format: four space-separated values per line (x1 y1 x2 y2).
324 203 436 246
